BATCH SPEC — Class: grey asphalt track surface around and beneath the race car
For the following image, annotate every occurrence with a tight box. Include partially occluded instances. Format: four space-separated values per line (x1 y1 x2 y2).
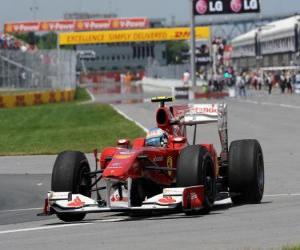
0 85 300 250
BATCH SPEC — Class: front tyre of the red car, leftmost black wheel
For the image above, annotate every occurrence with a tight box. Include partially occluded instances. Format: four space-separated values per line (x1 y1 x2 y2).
51 151 91 222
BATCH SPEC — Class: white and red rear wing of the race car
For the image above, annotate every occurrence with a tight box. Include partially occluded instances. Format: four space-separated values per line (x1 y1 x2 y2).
172 103 228 161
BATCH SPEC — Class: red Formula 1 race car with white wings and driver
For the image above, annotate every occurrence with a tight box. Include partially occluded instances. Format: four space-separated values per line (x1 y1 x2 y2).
40 97 264 221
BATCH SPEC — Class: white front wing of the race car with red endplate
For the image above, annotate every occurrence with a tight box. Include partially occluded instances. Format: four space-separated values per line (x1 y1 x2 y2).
44 186 204 215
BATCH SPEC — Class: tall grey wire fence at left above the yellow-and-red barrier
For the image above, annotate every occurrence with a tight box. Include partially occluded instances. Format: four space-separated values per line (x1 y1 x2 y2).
0 50 76 89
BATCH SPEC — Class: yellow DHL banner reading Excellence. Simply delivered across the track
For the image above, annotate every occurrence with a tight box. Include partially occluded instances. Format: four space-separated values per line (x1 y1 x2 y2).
59 27 210 45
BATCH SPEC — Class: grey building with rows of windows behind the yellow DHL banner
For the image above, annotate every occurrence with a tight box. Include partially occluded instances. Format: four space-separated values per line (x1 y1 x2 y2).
75 19 167 72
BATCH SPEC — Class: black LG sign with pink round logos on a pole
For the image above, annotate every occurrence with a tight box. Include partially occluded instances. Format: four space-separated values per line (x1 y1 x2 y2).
193 0 260 16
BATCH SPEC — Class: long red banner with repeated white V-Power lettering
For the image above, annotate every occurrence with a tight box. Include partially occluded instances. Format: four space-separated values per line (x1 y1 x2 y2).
4 17 149 33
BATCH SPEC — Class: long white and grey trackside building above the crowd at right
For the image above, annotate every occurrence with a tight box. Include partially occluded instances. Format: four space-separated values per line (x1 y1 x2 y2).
232 15 300 69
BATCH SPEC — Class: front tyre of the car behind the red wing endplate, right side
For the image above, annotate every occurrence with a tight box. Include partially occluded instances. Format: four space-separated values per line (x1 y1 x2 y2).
176 145 216 213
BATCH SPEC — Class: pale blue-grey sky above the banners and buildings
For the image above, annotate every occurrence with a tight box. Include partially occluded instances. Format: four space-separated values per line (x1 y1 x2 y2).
0 0 300 30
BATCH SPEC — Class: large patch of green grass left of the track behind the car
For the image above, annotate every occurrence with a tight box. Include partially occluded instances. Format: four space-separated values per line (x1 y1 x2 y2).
0 87 144 155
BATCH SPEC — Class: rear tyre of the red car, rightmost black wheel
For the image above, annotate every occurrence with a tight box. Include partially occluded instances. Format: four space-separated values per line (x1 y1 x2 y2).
228 140 264 204
